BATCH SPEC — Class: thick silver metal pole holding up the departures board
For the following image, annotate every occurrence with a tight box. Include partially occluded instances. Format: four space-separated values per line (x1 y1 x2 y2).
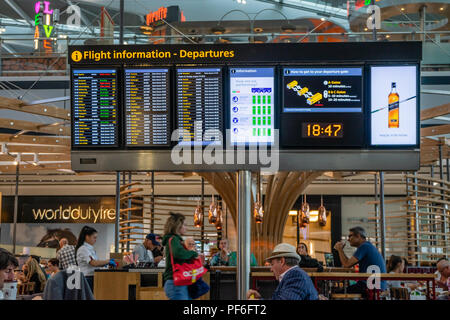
237 170 252 300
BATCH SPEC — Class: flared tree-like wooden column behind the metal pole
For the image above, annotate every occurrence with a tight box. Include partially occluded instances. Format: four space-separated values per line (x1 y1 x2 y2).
198 171 322 264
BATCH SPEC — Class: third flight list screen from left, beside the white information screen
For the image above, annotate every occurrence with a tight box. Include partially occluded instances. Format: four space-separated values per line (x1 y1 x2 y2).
176 68 223 146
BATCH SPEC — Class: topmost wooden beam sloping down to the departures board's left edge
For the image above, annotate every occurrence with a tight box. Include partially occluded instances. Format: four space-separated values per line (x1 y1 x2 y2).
0 97 70 120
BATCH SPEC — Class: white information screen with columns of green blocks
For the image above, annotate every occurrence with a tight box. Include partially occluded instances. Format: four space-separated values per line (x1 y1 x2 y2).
229 68 275 145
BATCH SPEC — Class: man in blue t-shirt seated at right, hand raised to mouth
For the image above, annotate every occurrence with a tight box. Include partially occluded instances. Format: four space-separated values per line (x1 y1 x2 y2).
334 227 387 296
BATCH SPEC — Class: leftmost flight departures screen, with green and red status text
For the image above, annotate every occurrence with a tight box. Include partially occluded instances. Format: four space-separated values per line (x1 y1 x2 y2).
72 69 118 147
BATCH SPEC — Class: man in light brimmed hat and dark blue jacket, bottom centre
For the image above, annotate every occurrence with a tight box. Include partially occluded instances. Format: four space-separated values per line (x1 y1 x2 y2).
247 243 318 300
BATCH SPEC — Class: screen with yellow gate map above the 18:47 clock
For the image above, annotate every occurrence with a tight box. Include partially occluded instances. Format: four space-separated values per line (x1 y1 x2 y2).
283 67 362 112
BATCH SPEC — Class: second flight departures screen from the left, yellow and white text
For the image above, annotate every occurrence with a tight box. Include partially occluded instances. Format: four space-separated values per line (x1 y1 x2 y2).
125 69 170 147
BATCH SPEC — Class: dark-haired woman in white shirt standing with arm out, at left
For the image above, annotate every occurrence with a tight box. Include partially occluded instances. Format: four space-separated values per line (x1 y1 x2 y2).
75 226 110 292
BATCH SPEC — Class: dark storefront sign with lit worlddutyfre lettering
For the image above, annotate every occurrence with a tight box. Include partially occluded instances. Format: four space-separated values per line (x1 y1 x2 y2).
1 196 121 223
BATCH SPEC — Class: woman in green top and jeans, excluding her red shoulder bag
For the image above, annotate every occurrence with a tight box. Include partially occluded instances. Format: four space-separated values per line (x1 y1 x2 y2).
162 212 198 300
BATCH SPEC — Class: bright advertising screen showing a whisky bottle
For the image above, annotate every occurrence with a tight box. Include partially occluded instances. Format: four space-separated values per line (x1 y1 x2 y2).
370 66 417 146
